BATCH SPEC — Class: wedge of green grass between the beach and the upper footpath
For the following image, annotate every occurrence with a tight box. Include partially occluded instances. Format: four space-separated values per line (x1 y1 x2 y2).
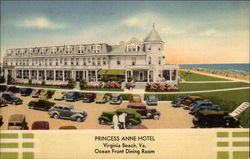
179 71 228 81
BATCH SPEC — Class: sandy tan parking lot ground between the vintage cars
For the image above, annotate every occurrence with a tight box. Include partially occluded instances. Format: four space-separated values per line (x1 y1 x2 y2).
0 94 193 130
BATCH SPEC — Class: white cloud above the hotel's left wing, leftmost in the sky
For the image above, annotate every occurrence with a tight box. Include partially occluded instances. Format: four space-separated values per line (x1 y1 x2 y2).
19 17 65 29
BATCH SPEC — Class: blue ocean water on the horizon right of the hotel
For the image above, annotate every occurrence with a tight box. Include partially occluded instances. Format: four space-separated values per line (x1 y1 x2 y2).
180 63 250 75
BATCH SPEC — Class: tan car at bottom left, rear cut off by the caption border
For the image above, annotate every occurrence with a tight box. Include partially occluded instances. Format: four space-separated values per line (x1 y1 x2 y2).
8 114 28 130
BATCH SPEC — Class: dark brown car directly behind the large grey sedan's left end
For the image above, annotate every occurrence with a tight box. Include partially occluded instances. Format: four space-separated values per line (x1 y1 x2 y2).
28 99 55 111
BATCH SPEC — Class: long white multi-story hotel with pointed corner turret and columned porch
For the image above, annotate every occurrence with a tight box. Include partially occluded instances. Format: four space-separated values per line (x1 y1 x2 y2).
3 27 179 83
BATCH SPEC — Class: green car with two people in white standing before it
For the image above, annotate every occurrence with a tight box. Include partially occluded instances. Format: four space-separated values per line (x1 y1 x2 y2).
98 108 141 128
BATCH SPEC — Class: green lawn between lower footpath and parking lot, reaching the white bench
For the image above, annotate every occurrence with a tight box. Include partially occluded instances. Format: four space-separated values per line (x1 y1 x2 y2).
145 89 250 128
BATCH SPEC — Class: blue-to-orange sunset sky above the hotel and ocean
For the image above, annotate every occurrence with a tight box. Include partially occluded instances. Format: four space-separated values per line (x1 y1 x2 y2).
1 1 250 64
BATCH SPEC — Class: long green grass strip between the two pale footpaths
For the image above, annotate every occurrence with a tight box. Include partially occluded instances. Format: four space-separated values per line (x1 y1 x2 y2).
177 82 249 92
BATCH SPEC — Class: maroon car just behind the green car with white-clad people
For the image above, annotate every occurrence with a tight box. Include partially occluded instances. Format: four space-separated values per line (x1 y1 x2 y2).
127 103 160 120
